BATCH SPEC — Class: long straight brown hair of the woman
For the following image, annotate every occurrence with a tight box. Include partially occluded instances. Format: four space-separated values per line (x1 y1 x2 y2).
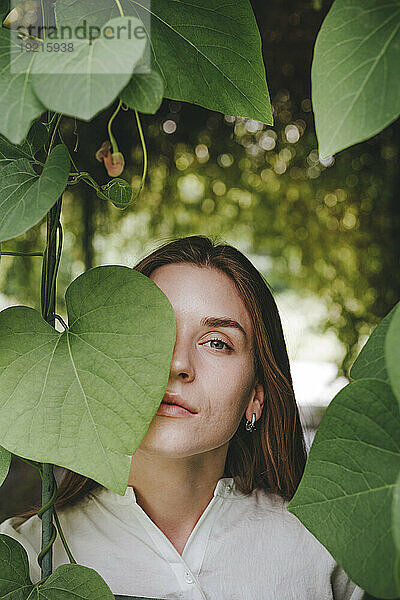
13 235 307 518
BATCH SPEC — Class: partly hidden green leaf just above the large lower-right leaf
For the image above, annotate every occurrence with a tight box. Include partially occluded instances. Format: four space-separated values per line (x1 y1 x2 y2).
350 307 396 383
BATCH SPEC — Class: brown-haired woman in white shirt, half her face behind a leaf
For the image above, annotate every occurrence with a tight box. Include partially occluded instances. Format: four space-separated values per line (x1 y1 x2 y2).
0 236 363 600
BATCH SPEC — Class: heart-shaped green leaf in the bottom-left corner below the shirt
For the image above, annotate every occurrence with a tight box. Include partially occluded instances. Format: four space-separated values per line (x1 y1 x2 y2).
0 534 114 600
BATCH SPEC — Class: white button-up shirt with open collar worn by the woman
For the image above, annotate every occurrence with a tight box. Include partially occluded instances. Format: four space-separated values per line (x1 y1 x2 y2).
0 477 363 600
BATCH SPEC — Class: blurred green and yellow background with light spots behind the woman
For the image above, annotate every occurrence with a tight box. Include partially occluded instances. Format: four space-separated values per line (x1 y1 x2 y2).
0 0 400 520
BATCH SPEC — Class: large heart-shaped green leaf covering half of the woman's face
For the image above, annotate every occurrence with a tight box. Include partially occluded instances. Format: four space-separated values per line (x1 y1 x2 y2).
0 265 175 495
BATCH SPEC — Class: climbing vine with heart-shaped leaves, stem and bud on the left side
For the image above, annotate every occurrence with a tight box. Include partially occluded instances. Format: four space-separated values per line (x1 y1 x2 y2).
0 0 272 600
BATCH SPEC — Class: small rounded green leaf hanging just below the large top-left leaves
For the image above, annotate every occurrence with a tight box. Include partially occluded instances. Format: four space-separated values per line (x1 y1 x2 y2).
119 71 164 114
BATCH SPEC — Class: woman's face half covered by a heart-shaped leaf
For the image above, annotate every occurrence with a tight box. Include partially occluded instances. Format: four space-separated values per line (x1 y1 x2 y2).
139 263 263 458
